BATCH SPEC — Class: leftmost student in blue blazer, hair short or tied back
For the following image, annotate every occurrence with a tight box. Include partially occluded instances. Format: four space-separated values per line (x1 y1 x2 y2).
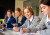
3 9 16 28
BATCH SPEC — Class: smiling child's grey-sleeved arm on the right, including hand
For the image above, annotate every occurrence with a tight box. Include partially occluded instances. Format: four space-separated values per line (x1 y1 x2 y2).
20 17 40 32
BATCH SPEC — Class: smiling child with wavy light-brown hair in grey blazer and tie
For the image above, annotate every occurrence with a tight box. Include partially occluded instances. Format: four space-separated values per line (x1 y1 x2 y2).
13 6 39 33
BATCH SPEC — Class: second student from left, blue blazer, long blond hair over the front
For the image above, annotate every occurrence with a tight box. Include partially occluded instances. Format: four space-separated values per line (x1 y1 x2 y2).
13 8 26 27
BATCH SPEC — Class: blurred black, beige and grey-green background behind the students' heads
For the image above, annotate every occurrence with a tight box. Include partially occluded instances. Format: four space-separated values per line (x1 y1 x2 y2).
0 0 41 19
